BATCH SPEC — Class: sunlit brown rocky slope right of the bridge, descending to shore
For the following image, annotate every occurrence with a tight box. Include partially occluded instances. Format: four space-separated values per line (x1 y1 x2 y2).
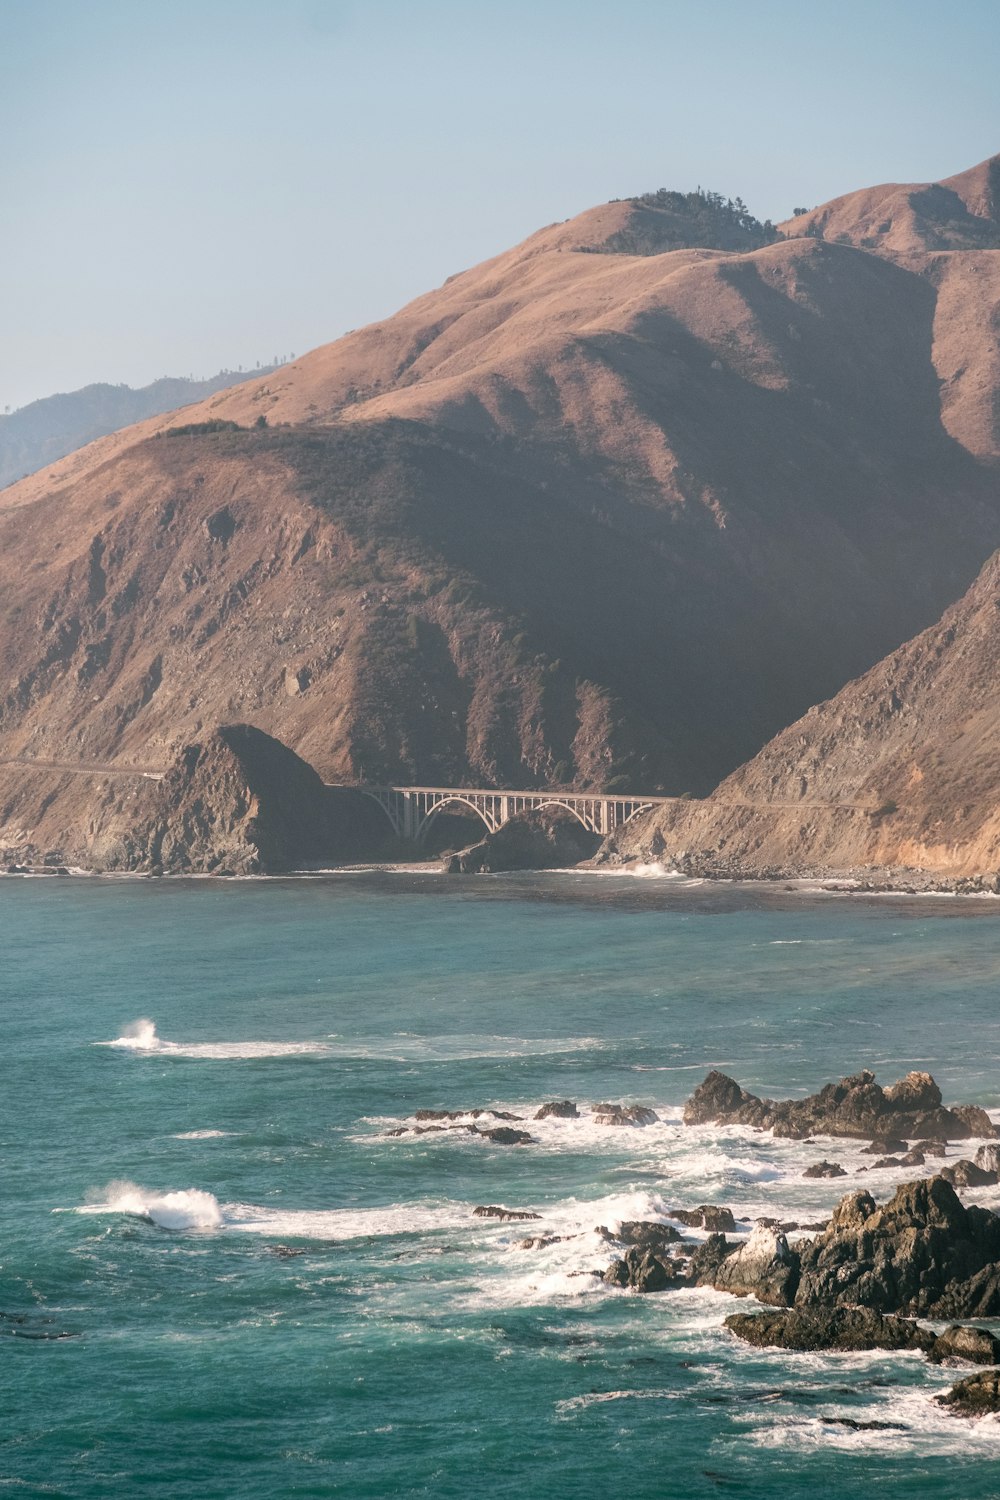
615 554 1000 881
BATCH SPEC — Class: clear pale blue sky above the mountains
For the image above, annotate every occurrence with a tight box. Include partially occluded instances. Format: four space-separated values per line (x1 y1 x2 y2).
0 0 1000 411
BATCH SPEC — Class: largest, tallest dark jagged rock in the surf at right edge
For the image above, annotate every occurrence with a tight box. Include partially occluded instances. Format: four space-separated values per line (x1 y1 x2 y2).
795 1178 1000 1317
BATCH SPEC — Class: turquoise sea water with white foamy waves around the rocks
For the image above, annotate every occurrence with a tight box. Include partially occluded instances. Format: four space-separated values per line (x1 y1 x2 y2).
0 875 1000 1500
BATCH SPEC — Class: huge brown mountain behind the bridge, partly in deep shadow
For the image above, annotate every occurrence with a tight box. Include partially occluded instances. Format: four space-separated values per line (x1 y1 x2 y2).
0 156 1000 828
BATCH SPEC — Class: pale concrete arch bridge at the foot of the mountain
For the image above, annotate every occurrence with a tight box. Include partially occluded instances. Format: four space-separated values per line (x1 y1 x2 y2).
346 786 673 843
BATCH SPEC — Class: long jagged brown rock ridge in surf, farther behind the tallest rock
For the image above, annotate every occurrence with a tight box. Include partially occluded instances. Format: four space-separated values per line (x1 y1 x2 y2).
684 1068 997 1143
